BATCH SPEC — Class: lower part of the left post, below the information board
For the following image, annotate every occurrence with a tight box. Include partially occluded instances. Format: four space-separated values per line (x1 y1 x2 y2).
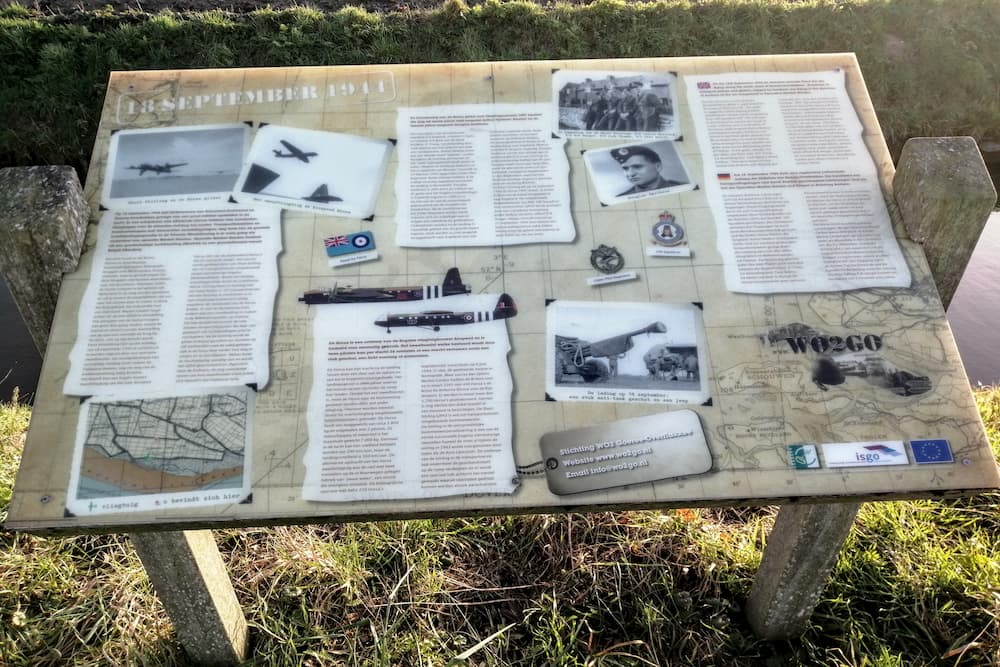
129 530 247 665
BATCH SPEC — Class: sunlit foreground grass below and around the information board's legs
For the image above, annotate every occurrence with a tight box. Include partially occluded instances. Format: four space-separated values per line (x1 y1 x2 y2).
0 388 1000 667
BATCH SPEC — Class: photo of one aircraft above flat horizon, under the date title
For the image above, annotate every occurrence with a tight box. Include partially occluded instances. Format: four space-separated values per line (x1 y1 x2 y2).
103 123 250 209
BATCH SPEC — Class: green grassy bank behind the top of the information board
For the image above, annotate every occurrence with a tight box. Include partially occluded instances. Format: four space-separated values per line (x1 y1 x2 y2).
0 0 1000 174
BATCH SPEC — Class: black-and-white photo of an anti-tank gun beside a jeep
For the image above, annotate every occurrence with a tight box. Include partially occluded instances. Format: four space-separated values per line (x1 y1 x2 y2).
546 300 708 404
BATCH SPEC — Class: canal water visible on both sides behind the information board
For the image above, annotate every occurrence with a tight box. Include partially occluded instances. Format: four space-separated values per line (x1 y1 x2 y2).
0 213 1000 401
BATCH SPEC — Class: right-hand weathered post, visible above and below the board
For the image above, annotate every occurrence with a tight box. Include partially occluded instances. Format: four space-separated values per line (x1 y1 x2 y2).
747 137 997 639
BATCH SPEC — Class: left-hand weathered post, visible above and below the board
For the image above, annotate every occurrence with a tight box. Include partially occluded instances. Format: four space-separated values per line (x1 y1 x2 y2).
0 167 247 665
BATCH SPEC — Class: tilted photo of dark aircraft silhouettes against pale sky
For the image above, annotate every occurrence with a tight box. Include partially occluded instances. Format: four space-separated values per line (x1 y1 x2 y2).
233 125 392 218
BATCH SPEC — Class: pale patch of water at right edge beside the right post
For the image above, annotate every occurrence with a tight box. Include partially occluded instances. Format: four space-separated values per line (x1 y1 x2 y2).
948 213 1000 385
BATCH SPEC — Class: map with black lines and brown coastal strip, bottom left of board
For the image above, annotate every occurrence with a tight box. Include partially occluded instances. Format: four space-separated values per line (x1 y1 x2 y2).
67 390 252 513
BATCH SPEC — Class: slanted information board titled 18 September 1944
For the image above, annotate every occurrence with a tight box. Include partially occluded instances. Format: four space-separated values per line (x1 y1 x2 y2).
7 54 998 532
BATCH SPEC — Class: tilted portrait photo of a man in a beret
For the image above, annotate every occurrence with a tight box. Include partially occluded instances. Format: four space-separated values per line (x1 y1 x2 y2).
583 141 696 206
